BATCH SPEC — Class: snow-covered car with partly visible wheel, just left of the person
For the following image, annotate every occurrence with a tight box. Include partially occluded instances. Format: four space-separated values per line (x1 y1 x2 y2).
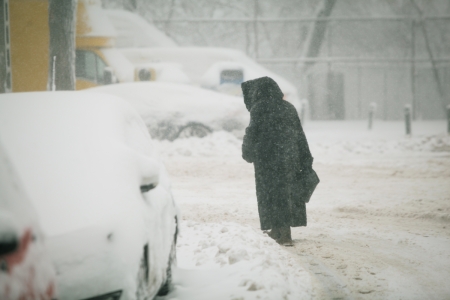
87 82 249 140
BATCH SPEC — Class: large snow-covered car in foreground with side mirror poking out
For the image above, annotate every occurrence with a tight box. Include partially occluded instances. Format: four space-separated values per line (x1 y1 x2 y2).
0 92 178 300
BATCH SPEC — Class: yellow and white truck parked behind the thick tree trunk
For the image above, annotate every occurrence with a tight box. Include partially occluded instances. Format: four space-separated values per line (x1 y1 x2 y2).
0 0 156 92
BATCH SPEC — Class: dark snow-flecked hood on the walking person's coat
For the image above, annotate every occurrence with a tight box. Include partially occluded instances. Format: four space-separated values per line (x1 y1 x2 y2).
241 77 284 111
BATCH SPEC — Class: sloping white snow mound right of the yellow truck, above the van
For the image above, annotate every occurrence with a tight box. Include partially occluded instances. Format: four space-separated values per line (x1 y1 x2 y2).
105 10 178 47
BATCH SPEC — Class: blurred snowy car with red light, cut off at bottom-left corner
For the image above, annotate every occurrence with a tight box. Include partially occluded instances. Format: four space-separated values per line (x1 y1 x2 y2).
0 144 55 300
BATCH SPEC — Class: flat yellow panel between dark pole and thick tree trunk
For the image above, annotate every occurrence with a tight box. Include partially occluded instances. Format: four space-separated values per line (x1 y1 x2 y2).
9 0 49 92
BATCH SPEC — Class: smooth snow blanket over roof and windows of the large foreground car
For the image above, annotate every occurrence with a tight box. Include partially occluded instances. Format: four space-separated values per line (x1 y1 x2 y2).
0 92 156 236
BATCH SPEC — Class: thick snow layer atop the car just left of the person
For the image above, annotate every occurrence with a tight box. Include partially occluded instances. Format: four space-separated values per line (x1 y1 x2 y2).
86 82 249 129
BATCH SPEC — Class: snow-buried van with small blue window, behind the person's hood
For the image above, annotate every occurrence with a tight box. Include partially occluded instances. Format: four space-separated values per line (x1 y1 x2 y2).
121 47 298 104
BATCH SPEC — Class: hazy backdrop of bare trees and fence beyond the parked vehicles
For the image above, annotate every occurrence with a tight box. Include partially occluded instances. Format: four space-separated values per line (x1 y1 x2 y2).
102 0 450 120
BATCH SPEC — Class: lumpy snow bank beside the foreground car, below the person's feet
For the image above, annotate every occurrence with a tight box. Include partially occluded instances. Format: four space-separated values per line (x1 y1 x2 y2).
159 221 313 300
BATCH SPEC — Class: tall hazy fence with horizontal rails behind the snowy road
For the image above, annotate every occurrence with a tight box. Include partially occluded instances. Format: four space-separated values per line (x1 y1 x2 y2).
153 15 450 120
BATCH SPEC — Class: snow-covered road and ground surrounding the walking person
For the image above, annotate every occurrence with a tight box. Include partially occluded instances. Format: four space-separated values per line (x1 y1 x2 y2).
158 121 450 300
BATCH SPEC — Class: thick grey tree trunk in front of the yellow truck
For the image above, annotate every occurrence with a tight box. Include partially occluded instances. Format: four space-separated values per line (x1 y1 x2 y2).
47 0 78 90
